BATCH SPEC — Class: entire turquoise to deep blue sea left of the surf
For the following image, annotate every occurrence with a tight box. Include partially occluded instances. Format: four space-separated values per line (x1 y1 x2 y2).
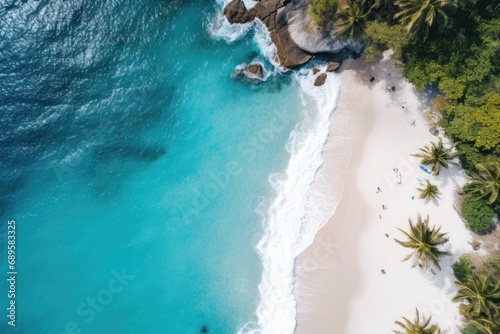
0 0 301 334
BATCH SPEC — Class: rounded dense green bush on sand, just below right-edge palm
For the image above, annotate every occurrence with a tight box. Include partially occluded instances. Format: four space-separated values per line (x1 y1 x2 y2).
460 194 495 234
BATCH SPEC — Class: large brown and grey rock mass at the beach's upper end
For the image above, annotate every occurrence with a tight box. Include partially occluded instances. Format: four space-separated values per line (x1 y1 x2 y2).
224 0 363 68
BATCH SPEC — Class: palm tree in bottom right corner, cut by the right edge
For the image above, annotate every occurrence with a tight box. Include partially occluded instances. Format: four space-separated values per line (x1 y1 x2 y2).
453 273 500 333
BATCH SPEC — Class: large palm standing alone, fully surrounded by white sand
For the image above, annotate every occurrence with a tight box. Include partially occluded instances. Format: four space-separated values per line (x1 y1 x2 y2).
394 215 451 271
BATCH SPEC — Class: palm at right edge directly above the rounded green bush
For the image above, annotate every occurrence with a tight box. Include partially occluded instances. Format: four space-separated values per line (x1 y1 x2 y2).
469 162 500 204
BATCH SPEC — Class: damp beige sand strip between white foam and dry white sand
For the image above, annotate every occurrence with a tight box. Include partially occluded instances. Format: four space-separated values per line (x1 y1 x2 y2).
296 59 374 333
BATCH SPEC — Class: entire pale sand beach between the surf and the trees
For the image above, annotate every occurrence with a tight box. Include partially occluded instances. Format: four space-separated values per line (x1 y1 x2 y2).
296 53 473 334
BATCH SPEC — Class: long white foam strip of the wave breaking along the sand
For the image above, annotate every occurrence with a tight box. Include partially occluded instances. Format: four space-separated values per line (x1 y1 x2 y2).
246 70 339 334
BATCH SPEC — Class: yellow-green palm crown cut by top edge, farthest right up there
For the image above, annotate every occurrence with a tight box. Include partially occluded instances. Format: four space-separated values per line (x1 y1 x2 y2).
394 0 457 38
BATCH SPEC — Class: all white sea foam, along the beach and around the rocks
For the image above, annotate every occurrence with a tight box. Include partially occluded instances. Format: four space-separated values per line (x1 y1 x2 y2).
210 1 346 334
